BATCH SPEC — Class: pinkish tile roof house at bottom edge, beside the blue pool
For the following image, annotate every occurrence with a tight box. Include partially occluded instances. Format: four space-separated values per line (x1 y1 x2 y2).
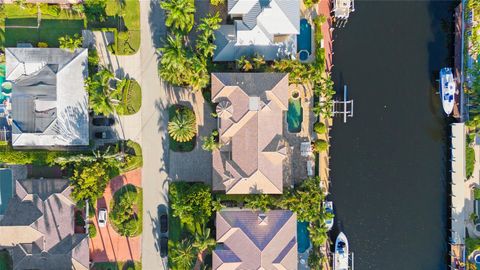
212 209 298 270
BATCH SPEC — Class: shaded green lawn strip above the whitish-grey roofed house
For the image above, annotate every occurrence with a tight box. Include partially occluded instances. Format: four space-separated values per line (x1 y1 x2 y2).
5 18 84 47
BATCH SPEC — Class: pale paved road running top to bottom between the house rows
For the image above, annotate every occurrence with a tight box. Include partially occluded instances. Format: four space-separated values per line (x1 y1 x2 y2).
139 0 168 270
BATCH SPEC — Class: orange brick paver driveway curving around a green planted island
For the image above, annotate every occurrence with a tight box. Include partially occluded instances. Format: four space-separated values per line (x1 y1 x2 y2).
89 169 142 262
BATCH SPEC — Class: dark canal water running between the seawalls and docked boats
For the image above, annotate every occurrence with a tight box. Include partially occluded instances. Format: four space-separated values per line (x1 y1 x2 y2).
330 0 455 270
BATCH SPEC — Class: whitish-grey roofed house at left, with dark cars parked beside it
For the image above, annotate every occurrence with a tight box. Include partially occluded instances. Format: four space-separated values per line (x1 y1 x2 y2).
5 48 89 148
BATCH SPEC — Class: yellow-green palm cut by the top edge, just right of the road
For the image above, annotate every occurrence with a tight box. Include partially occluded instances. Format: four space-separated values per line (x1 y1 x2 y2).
160 0 195 33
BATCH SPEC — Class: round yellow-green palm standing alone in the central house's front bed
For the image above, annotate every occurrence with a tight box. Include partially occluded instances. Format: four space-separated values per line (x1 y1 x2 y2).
168 107 197 142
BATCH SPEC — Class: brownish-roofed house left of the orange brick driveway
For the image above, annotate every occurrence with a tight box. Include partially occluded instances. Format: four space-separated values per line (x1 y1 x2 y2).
0 168 89 270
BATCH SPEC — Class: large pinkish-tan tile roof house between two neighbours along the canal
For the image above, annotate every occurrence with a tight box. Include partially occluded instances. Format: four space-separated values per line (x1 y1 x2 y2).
212 73 288 194
